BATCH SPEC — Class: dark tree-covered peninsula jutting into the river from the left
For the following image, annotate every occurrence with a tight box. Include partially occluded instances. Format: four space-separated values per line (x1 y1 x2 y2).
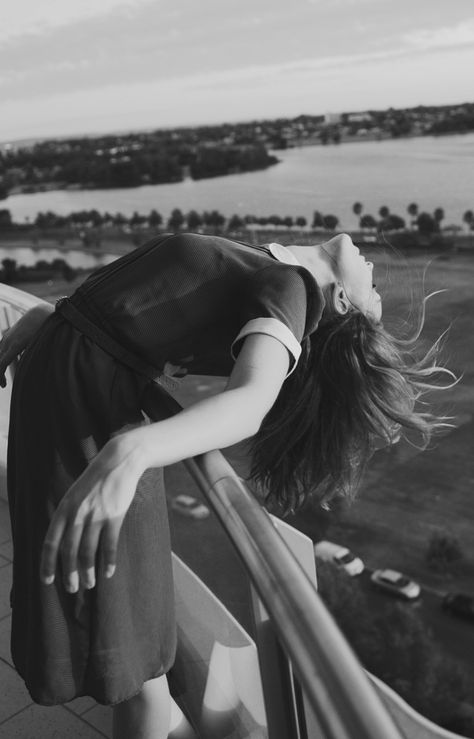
0 129 278 199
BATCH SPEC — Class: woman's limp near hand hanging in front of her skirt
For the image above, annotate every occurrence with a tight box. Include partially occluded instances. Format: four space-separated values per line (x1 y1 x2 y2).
41 433 145 593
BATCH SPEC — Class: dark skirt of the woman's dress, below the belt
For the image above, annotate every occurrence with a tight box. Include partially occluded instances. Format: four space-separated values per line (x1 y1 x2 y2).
8 313 176 705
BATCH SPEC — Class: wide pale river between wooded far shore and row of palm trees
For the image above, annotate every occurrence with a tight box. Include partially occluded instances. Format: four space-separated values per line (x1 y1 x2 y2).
0 133 474 229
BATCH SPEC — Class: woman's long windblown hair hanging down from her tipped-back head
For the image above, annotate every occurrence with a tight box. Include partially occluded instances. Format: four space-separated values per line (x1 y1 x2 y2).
251 304 456 514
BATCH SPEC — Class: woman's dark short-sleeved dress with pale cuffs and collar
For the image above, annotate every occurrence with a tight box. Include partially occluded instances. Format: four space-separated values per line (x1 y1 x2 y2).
8 234 324 705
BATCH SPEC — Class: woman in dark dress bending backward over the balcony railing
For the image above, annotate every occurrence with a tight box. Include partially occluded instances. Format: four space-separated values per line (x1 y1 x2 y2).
0 234 452 738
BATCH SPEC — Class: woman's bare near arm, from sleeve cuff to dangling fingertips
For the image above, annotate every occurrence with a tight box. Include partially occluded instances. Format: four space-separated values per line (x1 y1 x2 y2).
41 334 289 592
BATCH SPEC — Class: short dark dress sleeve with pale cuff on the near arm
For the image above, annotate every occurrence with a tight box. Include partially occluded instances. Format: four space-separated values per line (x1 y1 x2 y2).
231 265 308 374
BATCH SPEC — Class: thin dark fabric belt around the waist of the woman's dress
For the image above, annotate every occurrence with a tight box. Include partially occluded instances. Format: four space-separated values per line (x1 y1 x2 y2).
56 298 163 384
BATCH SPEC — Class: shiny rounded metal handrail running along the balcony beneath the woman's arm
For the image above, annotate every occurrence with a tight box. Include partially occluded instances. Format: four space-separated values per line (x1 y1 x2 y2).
2 287 401 739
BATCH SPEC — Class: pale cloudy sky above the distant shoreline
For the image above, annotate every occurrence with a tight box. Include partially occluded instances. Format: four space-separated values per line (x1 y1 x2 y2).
0 0 474 142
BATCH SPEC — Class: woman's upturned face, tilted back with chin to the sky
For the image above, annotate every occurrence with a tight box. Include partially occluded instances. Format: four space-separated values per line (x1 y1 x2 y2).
321 234 382 321
